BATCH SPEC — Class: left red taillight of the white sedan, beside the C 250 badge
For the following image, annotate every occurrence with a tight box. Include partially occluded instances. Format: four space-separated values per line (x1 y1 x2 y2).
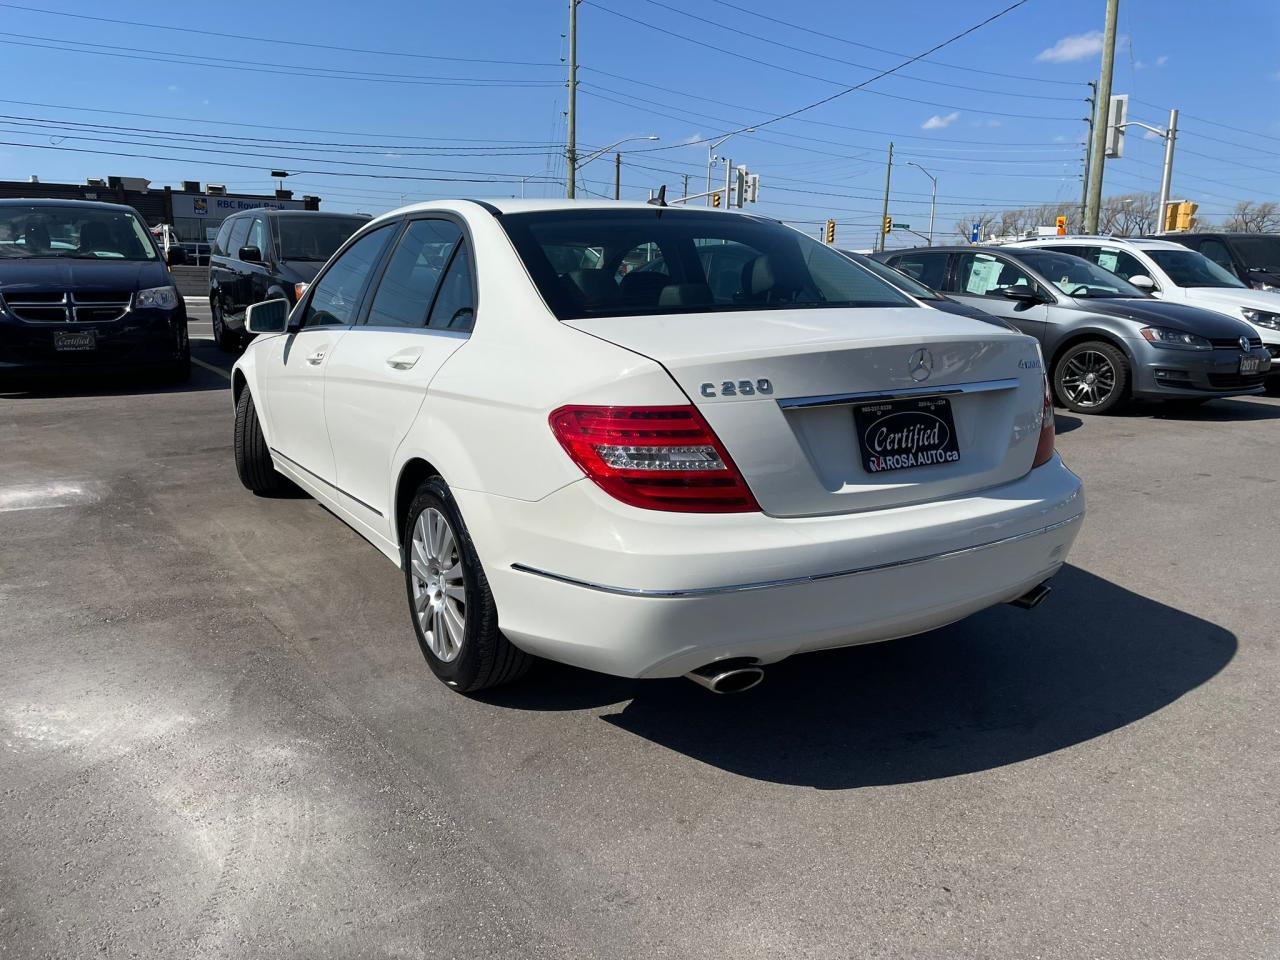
550 406 760 513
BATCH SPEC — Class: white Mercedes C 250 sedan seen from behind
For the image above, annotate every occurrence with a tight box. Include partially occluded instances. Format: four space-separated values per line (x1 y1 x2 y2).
233 201 1084 691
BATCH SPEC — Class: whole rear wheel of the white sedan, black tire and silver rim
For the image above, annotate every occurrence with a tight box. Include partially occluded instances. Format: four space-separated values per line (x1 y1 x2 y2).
401 476 534 694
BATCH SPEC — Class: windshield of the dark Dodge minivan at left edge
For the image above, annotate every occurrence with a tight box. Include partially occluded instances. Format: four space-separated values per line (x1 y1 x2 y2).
0 204 159 260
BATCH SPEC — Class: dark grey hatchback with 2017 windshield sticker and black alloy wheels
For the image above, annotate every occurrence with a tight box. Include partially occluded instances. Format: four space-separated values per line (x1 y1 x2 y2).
876 247 1271 413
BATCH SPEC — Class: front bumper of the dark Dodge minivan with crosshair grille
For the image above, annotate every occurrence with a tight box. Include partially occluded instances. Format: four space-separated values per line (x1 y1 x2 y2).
0 306 187 375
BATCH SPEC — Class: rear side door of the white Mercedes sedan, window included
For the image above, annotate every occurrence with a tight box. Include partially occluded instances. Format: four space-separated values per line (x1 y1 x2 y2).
325 218 476 536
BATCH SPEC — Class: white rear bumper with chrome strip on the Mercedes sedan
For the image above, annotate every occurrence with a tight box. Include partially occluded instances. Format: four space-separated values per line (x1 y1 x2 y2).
454 457 1084 677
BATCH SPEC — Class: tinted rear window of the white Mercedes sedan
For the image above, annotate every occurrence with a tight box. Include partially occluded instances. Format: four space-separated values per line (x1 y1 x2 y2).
502 207 914 320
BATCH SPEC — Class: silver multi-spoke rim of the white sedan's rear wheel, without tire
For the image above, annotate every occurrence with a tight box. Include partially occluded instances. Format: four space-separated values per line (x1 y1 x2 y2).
410 507 467 663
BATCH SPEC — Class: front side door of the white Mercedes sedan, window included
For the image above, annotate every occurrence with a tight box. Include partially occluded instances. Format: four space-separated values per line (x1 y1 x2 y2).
259 224 398 486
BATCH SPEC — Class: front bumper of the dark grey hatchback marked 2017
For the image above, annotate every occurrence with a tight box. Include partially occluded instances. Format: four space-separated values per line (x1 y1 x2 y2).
1129 340 1272 399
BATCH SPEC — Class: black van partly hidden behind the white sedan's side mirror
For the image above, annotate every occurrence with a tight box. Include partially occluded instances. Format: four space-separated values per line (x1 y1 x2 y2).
209 210 369 351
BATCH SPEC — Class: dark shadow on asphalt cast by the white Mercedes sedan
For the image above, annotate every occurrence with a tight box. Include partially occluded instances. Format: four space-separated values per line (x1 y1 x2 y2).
492 567 1236 790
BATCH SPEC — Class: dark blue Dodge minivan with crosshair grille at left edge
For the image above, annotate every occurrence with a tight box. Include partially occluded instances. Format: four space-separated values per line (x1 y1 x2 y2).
0 200 191 381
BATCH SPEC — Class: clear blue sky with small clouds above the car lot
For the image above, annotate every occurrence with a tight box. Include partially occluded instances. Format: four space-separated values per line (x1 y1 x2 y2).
0 0 1280 246
